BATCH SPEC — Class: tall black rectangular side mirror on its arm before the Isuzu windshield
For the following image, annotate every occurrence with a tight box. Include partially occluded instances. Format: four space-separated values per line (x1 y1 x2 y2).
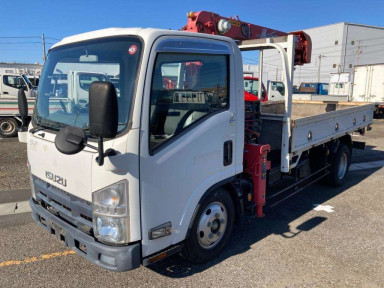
89 81 119 166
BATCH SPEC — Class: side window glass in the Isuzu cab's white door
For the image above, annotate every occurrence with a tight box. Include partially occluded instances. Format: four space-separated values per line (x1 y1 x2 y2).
149 53 229 152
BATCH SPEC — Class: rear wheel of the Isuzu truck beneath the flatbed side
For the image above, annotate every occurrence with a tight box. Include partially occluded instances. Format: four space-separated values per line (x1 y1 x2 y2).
328 144 351 187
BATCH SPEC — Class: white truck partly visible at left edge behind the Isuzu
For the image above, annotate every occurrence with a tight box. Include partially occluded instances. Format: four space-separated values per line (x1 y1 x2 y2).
0 74 37 137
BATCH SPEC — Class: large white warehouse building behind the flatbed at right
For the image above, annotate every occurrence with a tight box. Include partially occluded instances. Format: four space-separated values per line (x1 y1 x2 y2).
248 22 384 85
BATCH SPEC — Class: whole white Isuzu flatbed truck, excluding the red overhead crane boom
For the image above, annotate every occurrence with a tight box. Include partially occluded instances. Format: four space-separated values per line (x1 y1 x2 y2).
20 25 373 271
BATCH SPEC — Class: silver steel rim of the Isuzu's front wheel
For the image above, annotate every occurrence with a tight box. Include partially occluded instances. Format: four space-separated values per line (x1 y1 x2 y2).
197 202 228 249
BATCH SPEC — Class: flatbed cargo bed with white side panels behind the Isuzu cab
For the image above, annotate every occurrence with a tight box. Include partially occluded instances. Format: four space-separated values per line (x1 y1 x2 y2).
259 100 374 170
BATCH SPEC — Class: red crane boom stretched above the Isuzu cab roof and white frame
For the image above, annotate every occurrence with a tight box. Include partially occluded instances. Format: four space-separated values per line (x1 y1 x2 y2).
182 11 312 65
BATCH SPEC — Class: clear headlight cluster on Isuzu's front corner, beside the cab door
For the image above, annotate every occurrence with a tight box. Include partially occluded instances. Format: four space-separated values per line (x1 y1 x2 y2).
92 180 129 244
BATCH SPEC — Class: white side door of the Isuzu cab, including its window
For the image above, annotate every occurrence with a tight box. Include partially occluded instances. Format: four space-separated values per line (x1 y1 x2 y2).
140 36 243 257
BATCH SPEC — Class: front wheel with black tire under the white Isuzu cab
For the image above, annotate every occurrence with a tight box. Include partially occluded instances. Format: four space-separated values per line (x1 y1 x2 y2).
182 189 235 263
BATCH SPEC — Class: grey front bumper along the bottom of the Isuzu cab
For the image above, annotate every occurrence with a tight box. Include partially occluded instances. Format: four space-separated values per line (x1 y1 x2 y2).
29 198 141 272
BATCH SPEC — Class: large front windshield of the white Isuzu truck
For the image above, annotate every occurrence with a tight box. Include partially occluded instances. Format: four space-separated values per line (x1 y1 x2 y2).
33 37 141 133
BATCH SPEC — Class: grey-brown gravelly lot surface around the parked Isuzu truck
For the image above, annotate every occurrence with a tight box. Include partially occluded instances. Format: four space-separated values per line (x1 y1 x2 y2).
0 120 384 287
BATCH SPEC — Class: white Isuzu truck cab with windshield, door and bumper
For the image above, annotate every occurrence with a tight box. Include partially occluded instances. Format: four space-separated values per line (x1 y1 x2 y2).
27 29 244 271
